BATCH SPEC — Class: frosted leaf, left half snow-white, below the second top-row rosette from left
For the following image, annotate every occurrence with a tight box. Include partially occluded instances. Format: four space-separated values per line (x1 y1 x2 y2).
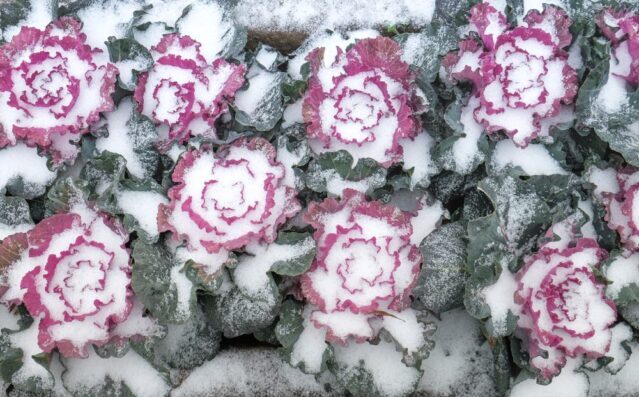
95 97 159 178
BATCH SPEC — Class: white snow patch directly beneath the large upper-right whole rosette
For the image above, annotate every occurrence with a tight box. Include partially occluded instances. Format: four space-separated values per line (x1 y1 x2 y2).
490 139 568 175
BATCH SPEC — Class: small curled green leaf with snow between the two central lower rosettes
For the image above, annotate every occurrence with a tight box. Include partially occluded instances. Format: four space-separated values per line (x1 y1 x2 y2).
271 232 315 276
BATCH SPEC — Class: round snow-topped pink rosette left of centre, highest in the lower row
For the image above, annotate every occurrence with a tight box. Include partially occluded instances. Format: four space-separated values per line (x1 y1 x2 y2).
158 138 301 272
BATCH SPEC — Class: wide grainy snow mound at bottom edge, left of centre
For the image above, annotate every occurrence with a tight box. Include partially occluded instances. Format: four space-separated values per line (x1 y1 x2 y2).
171 348 324 397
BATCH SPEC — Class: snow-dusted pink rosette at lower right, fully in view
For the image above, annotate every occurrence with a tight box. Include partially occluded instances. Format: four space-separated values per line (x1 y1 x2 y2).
515 229 617 380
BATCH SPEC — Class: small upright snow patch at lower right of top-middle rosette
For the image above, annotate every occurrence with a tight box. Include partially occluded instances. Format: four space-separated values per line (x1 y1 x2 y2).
399 131 439 189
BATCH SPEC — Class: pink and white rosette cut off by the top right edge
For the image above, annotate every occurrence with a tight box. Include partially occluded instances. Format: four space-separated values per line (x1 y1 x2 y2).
597 9 639 87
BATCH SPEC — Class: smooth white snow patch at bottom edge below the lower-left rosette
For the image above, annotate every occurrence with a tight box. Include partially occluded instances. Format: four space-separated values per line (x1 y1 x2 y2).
62 349 170 397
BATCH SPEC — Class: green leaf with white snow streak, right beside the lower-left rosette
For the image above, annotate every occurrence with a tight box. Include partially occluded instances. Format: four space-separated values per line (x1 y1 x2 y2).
131 240 196 324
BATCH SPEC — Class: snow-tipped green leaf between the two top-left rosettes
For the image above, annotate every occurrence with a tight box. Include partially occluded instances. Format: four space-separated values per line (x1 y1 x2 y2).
106 37 153 91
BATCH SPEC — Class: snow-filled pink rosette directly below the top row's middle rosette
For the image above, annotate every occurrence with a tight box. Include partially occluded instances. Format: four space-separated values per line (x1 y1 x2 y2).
301 189 422 344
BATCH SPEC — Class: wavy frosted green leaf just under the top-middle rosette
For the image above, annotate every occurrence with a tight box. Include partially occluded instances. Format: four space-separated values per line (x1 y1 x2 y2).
305 150 386 195
